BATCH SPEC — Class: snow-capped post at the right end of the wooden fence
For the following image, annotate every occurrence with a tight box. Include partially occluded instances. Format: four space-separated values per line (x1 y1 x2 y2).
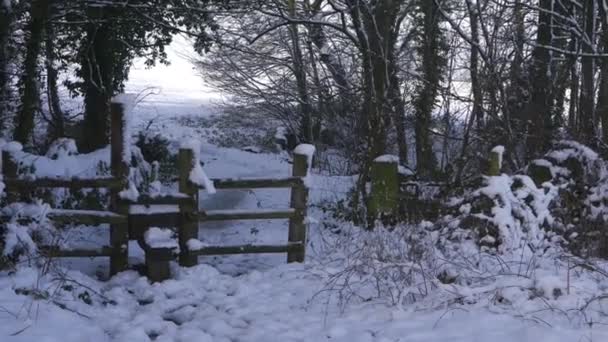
287 144 315 262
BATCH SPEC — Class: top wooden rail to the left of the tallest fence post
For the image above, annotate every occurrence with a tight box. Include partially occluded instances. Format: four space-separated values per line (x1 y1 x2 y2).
4 178 121 190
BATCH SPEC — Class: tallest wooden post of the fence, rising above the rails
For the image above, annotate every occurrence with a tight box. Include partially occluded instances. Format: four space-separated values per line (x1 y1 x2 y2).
110 102 130 275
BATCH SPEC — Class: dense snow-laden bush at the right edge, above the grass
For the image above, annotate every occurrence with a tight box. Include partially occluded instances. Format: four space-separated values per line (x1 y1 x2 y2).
438 141 608 254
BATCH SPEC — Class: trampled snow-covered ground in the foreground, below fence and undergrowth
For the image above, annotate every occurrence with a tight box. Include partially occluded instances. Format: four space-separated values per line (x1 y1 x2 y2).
0 265 608 342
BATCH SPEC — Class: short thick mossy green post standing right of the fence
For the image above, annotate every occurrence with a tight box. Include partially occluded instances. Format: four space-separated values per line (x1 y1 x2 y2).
367 155 399 226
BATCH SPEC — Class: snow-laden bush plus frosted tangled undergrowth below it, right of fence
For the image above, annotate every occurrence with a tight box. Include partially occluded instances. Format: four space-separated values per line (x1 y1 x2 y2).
323 141 608 316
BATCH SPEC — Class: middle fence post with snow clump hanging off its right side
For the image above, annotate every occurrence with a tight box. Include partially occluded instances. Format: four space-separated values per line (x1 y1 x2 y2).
178 148 198 267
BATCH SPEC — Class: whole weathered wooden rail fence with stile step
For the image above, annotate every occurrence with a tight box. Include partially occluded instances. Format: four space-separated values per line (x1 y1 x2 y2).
2 99 309 281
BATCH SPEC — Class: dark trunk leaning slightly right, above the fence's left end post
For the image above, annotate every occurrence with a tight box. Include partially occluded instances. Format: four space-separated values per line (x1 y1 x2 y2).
13 0 49 145
